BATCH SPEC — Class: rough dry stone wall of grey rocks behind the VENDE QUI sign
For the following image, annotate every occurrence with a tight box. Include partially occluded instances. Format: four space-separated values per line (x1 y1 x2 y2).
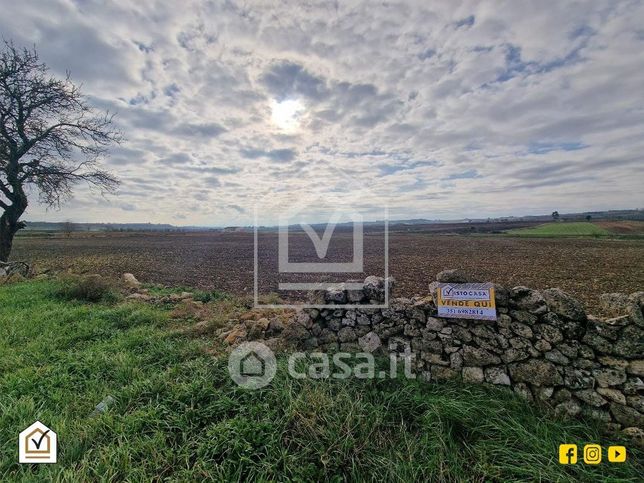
284 270 644 438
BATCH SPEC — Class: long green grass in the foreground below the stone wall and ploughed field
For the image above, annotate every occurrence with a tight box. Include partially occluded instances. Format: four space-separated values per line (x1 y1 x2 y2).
0 281 642 481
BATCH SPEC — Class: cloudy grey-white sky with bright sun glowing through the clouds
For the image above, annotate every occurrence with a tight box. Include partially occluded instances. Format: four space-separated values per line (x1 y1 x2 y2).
0 0 644 225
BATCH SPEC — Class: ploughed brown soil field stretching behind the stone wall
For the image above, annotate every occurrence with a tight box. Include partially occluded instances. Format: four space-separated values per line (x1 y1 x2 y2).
12 232 644 311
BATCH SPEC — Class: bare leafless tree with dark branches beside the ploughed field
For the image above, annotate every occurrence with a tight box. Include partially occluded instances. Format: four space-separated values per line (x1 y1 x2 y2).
0 42 121 261
